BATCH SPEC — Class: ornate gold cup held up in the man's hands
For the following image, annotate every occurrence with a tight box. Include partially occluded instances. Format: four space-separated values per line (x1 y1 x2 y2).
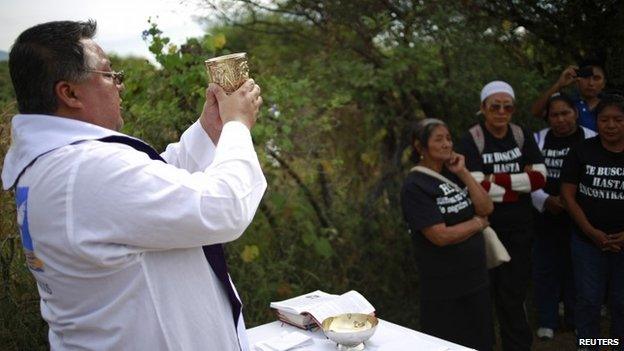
205 52 249 94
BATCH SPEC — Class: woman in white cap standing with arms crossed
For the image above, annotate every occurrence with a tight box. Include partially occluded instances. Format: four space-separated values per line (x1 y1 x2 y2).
459 81 546 351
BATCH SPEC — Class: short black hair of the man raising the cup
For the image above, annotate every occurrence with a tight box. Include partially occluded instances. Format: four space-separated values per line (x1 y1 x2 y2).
9 20 97 114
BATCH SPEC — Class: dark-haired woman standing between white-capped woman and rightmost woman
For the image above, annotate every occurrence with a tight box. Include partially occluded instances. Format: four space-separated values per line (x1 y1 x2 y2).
531 94 596 339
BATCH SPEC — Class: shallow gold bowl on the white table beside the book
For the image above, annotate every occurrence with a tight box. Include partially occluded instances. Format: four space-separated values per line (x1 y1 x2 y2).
321 313 379 351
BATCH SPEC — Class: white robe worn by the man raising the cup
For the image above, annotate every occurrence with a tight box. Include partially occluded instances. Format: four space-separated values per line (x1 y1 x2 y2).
2 115 266 351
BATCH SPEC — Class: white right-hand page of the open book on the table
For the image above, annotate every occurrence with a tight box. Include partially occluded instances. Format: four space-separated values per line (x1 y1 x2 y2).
306 290 375 325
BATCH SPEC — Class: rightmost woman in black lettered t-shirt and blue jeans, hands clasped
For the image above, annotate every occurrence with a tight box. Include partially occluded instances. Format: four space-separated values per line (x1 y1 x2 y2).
561 95 624 350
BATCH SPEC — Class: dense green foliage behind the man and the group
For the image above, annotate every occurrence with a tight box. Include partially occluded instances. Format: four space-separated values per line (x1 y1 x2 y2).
0 0 621 349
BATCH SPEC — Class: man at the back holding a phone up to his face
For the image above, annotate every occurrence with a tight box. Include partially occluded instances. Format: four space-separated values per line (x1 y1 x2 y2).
531 60 606 131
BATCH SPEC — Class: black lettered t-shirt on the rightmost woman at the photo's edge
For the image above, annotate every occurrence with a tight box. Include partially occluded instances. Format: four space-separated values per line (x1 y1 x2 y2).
560 136 624 240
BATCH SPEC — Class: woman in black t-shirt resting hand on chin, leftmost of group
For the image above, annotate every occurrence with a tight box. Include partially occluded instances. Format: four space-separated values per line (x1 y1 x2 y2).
401 119 493 350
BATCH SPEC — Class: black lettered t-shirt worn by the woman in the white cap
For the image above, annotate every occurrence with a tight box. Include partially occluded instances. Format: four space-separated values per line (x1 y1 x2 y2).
458 122 544 230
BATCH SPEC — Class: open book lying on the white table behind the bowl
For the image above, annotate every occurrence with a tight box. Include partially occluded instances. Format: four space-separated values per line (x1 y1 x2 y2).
270 290 375 329
